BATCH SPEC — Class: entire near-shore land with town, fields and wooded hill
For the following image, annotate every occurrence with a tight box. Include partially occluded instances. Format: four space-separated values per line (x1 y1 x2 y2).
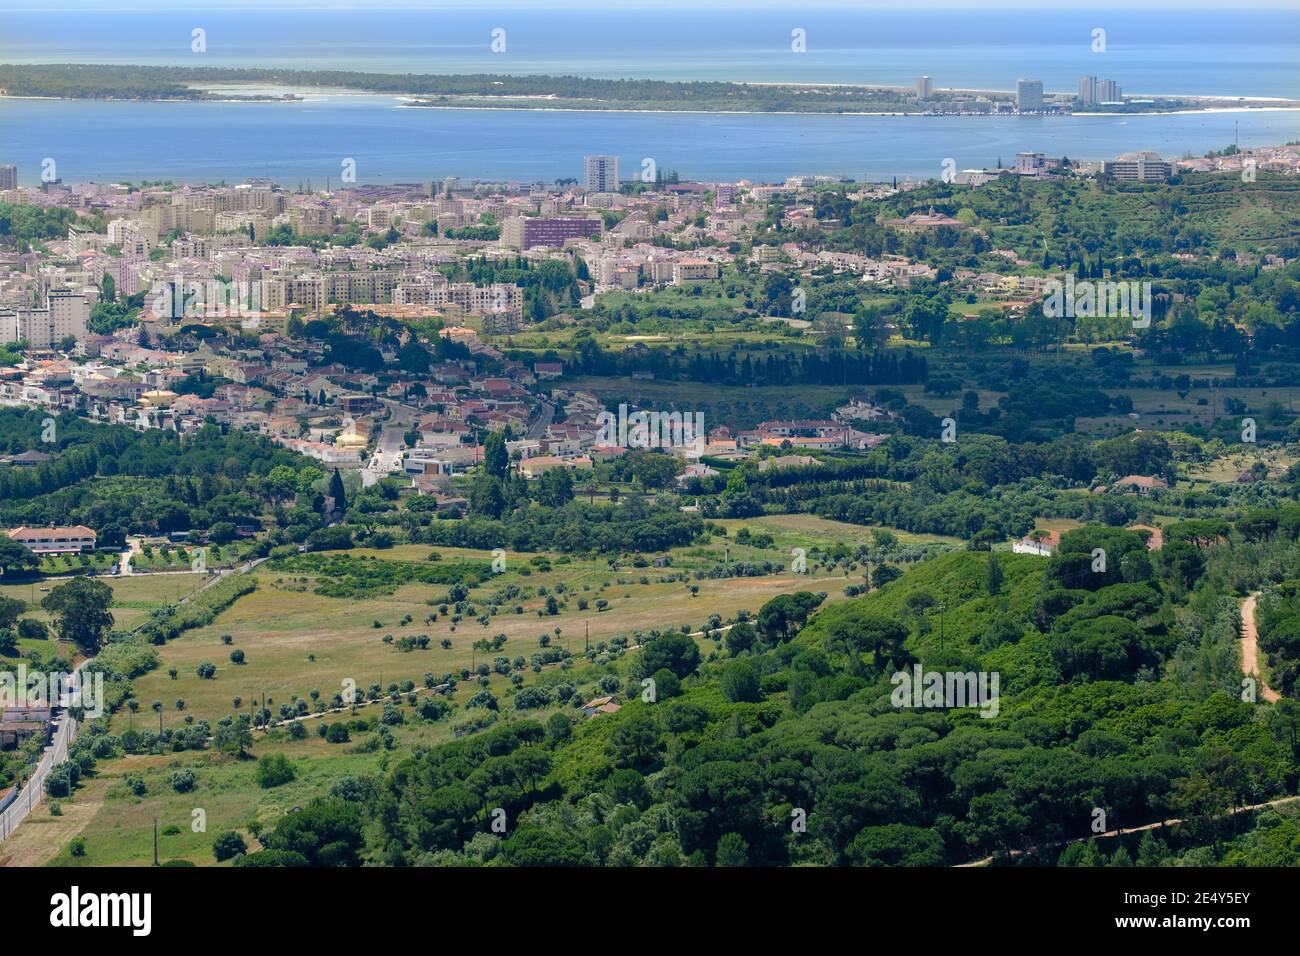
0 102 1300 889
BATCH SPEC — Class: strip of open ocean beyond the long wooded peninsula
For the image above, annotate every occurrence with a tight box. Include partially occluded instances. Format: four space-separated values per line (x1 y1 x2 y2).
0 5 1300 99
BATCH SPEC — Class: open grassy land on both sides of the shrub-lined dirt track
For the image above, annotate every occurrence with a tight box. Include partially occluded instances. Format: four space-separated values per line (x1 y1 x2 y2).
12 535 873 866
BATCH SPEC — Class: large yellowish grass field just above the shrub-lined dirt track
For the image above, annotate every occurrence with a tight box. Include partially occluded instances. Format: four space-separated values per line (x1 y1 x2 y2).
114 541 857 730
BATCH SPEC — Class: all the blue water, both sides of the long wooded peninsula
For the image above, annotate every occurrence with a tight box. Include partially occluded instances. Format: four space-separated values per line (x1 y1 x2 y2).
0 0 1300 186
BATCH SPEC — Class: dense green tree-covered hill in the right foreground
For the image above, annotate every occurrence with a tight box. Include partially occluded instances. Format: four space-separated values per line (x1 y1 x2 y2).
317 535 1291 865
